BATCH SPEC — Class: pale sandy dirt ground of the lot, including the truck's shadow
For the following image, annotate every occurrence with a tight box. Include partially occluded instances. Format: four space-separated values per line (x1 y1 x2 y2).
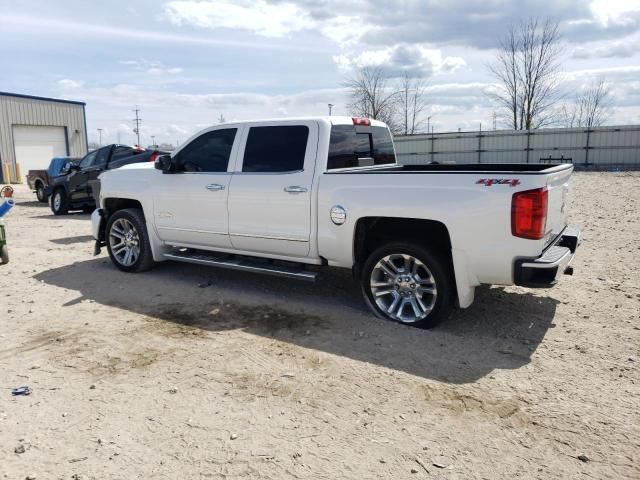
0 173 640 480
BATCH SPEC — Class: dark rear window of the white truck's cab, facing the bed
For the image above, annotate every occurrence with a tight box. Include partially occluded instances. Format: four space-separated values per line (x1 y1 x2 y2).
327 125 396 170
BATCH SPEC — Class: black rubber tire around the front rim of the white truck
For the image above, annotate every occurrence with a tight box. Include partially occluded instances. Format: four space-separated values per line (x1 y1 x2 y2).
105 208 154 273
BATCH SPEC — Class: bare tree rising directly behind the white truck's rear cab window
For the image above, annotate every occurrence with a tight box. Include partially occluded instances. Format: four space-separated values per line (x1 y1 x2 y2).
345 67 398 130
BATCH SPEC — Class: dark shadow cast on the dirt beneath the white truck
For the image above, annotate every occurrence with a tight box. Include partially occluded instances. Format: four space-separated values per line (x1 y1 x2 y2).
34 257 558 383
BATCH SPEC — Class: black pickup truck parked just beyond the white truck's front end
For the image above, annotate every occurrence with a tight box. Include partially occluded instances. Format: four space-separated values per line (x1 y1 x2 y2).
50 144 164 215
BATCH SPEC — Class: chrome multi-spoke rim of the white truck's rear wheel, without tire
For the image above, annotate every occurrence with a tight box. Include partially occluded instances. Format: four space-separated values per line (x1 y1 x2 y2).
369 253 438 323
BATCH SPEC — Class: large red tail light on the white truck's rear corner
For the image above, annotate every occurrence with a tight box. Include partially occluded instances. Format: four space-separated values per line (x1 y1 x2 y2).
511 188 547 240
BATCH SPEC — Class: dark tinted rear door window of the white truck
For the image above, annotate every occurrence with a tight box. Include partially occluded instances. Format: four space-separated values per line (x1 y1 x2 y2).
242 125 309 173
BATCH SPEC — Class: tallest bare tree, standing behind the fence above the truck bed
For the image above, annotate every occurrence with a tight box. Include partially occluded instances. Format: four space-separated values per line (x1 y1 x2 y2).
489 18 561 130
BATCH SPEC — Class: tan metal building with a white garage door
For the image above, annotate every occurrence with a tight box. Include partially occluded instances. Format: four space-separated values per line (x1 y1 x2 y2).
0 92 87 183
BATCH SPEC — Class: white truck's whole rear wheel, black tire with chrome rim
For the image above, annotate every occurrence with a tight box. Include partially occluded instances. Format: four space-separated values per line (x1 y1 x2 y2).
360 242 455 328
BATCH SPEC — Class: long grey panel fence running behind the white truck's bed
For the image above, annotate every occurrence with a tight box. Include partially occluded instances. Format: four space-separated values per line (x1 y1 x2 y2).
394 125 640 169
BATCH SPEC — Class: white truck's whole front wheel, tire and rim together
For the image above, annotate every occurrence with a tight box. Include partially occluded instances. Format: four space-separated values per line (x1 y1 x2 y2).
105 208 153 273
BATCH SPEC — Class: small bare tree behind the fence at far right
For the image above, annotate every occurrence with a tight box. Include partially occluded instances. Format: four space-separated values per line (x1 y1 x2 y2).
562 79 611 128
